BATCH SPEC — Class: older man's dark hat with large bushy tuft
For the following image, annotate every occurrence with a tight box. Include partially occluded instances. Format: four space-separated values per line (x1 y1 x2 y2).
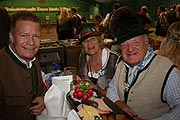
109 7 147 44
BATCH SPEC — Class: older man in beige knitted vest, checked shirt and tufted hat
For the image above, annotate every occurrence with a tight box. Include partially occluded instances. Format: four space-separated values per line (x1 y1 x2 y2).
106 7 180 120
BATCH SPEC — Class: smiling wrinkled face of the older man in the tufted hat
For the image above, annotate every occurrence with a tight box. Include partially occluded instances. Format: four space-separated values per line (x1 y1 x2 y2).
120 35 148 66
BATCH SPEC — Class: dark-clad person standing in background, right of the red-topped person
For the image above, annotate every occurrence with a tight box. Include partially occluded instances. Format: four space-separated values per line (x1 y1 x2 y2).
155 5 169 37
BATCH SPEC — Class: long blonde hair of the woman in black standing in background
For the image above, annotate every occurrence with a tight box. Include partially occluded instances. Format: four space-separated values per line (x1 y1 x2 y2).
58 7 69 25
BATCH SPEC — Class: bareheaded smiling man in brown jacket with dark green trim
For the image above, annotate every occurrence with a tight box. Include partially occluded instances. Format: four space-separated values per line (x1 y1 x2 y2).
0 11 46 120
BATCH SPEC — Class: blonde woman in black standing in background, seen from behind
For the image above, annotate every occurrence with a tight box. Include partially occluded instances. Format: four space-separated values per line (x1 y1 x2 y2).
57 7 74 40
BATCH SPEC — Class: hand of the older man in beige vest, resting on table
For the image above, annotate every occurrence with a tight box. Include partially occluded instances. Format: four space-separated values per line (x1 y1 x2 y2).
115 100 137 117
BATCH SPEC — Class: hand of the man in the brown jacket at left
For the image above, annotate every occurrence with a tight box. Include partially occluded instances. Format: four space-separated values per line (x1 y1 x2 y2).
29 96 45 115
